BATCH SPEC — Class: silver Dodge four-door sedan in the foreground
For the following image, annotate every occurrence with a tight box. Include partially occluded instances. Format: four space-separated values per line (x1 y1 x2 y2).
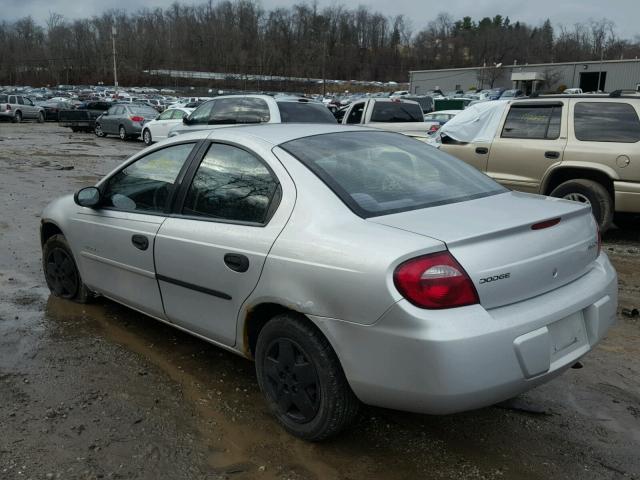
41 124 617 440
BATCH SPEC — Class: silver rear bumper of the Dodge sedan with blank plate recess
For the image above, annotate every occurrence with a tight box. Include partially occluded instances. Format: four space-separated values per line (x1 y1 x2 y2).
311 254 617 414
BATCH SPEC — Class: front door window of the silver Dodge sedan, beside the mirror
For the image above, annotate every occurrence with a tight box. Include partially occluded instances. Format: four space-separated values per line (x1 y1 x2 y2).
102 143 195 213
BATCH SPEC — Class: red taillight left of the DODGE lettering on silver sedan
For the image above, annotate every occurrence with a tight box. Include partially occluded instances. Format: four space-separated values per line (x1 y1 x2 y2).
393 251 479 309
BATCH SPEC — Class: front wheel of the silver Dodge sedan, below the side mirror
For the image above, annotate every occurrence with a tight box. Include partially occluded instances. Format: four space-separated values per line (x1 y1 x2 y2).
42 234 93 303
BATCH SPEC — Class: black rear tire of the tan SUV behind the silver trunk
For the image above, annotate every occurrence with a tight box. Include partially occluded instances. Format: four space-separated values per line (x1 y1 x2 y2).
551 178 613 232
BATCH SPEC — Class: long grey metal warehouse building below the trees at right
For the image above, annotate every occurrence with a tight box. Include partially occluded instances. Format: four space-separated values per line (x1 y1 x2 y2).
409 59 640 95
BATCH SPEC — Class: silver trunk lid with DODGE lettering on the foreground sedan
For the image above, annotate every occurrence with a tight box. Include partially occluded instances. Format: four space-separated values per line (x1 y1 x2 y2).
368 192 598 308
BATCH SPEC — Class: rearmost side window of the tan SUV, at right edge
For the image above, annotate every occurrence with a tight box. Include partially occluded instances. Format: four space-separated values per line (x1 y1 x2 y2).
573 102 640 143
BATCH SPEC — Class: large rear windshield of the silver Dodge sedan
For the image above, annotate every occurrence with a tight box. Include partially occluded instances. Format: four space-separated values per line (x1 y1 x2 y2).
281 132 507 218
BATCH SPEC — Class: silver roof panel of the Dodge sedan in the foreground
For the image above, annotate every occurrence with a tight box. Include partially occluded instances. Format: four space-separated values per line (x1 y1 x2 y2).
172 123 370 147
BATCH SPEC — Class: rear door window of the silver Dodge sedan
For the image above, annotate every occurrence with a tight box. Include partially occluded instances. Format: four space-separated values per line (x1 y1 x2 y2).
182 144 279 224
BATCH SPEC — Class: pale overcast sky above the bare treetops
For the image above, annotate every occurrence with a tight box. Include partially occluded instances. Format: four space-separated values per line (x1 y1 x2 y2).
5 0 640 39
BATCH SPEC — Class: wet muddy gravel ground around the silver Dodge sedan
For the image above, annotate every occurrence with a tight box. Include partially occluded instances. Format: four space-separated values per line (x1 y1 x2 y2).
0 123 640 480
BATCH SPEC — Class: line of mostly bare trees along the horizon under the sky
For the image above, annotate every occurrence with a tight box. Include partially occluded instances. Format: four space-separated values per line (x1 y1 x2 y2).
0 0 640 85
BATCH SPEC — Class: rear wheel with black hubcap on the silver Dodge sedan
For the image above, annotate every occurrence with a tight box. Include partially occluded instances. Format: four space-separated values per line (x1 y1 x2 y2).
256 313 360 442
